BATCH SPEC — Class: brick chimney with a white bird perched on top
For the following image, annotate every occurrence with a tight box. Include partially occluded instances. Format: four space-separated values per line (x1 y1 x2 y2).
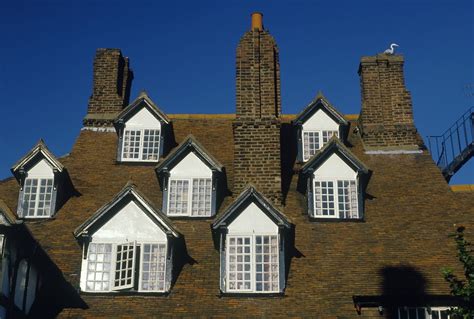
359 54 423 151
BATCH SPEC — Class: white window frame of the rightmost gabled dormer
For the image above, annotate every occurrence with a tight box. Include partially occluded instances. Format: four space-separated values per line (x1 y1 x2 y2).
311 176 360 219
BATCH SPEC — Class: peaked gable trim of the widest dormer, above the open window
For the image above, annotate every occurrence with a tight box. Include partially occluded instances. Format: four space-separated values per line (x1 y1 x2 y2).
74 182 181 238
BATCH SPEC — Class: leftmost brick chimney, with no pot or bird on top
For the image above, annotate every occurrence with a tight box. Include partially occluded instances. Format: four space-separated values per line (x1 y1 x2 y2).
83 49 133 127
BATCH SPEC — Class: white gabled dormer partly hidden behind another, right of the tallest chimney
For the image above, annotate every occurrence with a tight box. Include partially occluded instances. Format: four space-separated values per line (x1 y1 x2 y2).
293 93 348 162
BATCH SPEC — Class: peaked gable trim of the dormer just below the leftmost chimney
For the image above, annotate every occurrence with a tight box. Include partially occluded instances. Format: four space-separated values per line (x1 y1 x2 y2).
114 91 171 129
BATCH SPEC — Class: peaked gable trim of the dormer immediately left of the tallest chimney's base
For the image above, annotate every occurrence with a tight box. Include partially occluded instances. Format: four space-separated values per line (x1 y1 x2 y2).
155 134 224 175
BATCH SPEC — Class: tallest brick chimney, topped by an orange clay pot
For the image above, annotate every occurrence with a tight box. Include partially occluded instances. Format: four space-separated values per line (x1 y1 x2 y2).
233 13 282 204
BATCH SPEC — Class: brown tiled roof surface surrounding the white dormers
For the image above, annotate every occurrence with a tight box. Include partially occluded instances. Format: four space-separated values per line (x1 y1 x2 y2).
0 115 474 318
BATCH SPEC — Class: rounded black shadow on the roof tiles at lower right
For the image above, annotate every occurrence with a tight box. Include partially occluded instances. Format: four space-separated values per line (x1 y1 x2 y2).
380 266 426 319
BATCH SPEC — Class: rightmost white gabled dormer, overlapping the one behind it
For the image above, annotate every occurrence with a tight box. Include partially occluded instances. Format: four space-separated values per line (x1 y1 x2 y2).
298 137 369 220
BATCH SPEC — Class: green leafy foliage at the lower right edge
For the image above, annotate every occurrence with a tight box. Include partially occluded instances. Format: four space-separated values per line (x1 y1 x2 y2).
443 226 474 319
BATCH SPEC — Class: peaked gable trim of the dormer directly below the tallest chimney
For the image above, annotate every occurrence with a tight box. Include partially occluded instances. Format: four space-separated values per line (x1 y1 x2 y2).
211 184 291 230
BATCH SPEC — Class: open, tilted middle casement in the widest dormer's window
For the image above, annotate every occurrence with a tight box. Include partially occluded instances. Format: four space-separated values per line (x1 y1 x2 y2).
114 243 135 288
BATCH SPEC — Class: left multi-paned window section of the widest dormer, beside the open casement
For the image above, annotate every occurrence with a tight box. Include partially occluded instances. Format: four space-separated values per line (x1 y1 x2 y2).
86 243 112 291
